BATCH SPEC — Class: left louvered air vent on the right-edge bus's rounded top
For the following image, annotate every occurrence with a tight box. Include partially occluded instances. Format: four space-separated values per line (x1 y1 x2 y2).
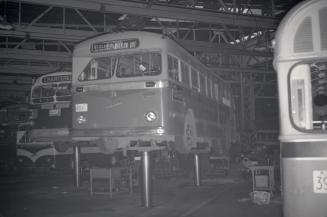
294 17 313 53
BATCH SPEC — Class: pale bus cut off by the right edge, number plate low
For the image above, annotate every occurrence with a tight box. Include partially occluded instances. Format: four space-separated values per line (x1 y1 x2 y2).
274 0 327 217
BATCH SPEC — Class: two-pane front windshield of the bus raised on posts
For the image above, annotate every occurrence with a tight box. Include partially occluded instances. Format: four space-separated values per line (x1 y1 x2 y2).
78 52 161 81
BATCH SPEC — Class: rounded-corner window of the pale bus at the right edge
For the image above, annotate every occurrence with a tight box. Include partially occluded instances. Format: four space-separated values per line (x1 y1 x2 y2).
289 61 327 130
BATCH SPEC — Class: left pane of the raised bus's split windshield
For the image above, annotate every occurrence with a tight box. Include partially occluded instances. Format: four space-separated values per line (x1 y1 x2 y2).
78 57 116 81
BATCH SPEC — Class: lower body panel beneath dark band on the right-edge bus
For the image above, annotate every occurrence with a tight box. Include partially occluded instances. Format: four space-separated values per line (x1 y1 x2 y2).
281 146 327 217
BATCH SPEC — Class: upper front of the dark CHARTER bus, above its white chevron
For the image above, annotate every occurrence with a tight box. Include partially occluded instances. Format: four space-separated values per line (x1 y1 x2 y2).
29 72 71 149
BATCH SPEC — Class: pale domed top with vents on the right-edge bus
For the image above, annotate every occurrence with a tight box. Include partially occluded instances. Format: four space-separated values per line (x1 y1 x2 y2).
274 0 327 68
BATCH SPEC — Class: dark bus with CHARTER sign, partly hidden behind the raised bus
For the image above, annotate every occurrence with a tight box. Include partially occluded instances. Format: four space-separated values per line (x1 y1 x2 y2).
17 71 113 169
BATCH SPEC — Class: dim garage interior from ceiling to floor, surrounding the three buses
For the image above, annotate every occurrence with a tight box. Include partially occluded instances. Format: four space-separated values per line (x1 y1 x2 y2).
0 0 300 217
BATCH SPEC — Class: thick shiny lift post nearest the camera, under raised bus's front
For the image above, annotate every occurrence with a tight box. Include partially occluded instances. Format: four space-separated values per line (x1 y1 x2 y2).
141 151 152 208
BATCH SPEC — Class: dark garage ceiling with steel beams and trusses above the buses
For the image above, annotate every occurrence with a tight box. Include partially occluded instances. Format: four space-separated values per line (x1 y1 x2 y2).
0 0 302 100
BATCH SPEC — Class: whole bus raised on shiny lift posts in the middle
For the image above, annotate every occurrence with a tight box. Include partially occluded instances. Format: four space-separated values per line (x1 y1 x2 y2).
72 31 234 163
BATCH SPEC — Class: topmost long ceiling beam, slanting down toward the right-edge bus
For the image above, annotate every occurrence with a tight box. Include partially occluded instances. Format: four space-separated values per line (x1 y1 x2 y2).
21 0 278 29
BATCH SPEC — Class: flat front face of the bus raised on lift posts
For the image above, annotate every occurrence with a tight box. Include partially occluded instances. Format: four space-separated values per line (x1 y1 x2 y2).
72 32 166 152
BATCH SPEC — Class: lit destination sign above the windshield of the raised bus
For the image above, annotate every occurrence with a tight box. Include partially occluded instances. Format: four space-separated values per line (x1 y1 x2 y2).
90 38 139 53
